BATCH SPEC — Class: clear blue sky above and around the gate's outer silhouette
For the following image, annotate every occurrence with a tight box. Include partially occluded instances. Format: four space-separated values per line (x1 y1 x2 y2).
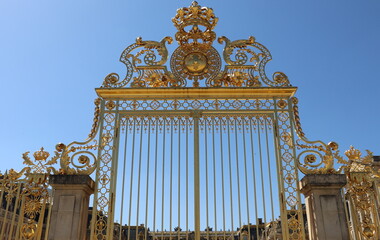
0 0 380 172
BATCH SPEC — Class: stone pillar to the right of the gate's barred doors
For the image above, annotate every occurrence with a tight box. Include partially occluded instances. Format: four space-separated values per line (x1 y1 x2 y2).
300 174 350 240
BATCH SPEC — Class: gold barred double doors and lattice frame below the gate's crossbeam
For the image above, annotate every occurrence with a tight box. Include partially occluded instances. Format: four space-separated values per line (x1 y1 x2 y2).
87 92 304 239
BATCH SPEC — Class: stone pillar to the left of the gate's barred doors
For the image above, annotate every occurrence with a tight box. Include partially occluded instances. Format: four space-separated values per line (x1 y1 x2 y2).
49 175 95 240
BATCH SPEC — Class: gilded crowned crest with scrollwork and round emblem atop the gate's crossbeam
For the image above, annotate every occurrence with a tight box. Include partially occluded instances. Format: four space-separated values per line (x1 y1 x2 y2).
102 1 290 88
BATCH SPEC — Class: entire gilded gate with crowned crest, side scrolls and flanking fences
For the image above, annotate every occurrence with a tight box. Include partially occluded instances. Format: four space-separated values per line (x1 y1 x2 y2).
0 2 380 240
